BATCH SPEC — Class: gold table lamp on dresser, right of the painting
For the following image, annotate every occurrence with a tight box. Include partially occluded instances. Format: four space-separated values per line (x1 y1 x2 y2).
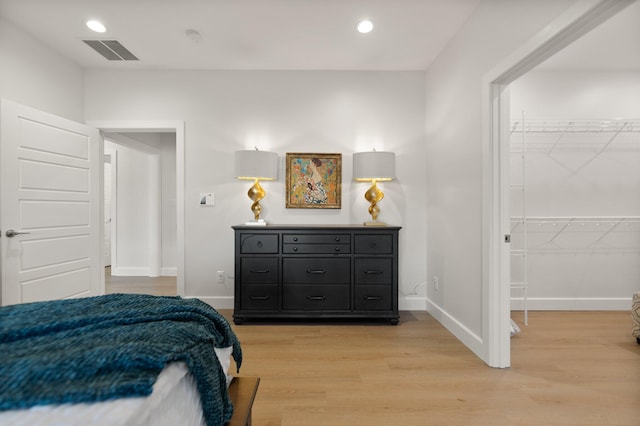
353 151 396 226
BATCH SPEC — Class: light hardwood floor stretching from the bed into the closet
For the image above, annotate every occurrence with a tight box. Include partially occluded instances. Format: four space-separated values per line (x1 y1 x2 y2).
102 274 640 426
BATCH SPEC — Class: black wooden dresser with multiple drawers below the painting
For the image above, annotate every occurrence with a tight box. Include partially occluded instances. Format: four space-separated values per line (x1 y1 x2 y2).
232 225 400 325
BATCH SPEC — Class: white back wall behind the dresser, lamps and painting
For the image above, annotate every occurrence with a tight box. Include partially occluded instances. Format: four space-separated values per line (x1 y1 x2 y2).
85 70 426 309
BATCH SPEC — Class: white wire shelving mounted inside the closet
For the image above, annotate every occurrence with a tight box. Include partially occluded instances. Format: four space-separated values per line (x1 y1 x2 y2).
511 117 640 325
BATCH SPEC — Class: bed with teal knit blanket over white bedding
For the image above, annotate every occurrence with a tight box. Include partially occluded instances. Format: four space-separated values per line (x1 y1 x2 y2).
0 294 257 426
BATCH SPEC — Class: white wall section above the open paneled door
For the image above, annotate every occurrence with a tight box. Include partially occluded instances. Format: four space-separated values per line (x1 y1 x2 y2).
0 17 84 122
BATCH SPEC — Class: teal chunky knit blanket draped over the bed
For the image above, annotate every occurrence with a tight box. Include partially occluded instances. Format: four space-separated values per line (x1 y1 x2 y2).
0 294 242 426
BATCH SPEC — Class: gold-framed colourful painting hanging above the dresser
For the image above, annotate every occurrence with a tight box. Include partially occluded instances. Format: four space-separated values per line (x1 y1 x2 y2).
286 152 342 209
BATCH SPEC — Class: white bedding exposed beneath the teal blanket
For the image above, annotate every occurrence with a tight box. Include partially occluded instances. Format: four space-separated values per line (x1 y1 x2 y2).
0 347 232 426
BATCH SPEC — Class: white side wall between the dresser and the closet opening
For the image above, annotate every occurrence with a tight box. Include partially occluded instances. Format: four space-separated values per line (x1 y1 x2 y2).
425 0 573 361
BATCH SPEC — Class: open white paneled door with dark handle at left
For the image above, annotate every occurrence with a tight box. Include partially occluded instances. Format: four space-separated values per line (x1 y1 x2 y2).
0 100 104 305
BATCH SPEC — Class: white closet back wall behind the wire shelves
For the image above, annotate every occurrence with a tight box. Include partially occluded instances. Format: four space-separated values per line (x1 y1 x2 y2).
511 71 640 310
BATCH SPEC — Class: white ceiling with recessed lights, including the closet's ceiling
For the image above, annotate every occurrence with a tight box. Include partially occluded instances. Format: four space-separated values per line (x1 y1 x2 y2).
0 0 640 70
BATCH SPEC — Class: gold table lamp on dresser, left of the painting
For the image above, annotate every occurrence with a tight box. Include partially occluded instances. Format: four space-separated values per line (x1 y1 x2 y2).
235 148 278 226
